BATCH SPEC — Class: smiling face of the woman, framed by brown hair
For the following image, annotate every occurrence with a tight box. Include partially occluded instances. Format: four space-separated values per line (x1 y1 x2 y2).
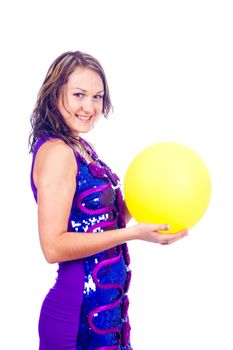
57 67 104 136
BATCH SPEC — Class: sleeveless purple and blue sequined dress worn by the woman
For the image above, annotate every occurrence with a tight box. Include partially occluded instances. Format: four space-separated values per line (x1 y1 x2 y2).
31 137 132 350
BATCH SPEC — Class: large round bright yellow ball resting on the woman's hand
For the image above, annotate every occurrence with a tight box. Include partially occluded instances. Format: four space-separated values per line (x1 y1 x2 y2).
124 142 211 233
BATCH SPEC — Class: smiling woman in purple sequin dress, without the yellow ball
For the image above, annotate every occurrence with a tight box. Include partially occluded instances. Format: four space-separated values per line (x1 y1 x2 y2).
30 51 187 350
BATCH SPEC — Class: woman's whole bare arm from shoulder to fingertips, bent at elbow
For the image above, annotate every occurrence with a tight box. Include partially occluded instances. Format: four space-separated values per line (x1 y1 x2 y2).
33 140 186 263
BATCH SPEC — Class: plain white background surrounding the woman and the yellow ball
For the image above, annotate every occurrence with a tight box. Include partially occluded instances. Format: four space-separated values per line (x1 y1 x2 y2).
0 0 233 350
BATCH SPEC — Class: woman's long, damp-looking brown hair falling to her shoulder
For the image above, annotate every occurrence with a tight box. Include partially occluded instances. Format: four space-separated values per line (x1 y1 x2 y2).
29 51 112 152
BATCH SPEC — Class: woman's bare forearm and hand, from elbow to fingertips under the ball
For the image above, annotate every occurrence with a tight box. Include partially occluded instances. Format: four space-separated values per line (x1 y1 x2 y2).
41 223 188 263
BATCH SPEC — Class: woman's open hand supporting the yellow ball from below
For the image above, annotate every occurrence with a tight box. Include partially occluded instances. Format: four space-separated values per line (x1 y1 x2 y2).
131 223 188 244
